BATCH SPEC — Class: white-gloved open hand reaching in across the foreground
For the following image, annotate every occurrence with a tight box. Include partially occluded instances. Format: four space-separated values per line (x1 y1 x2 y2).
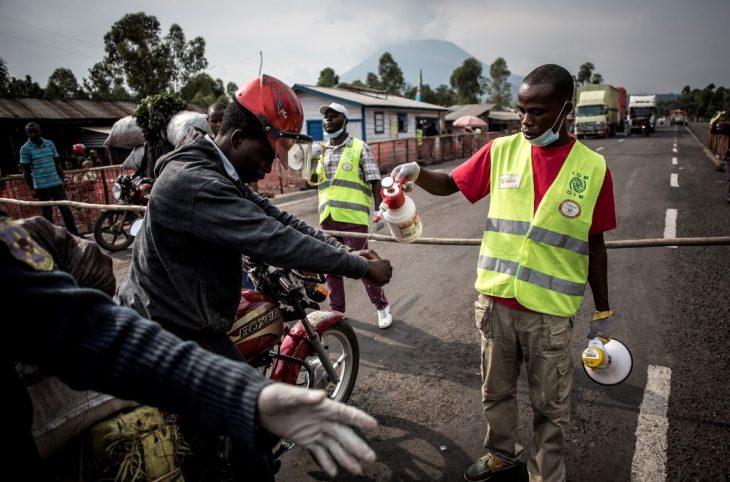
257 383 378 477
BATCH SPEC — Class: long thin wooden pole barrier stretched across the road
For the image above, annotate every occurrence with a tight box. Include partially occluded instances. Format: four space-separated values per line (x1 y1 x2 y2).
0 198 730 249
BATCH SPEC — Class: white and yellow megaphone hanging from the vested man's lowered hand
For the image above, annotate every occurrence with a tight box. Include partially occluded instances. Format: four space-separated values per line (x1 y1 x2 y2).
581 337 634 386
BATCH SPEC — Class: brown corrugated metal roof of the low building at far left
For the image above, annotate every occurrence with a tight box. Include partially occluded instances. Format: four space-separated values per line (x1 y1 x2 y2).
0 97 137 120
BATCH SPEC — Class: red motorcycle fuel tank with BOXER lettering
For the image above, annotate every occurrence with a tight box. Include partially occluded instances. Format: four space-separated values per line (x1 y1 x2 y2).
228 290 284 360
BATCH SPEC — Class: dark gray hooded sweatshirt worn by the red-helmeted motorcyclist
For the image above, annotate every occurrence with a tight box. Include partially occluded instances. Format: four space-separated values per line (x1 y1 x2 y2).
117 136 367 351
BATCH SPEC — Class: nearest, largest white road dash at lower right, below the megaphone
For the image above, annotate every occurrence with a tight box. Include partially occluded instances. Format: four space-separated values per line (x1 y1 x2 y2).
631 365 672 482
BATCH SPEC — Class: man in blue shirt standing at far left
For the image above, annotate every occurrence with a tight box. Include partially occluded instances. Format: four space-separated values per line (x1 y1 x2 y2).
20 122 79 236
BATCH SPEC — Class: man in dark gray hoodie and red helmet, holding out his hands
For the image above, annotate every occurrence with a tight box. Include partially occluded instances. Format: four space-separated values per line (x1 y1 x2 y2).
118 75 392 359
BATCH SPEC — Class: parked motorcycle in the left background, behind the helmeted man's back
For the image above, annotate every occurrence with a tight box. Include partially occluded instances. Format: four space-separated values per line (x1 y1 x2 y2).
94 175 154 251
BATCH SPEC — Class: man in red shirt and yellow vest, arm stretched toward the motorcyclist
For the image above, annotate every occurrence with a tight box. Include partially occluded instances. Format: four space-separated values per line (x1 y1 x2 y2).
392 64 616 482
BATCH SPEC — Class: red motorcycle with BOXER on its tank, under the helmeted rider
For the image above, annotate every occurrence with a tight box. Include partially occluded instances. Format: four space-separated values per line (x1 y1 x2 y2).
228 257 360 403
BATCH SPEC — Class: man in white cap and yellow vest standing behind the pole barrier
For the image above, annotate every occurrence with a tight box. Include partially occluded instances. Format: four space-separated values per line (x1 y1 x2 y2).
315 102 393 328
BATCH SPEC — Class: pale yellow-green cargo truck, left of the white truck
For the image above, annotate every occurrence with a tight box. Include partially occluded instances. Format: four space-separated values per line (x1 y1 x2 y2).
574 84 626 139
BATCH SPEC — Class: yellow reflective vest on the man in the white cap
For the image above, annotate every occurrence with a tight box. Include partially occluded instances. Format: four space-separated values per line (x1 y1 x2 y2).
315 138 373 226
